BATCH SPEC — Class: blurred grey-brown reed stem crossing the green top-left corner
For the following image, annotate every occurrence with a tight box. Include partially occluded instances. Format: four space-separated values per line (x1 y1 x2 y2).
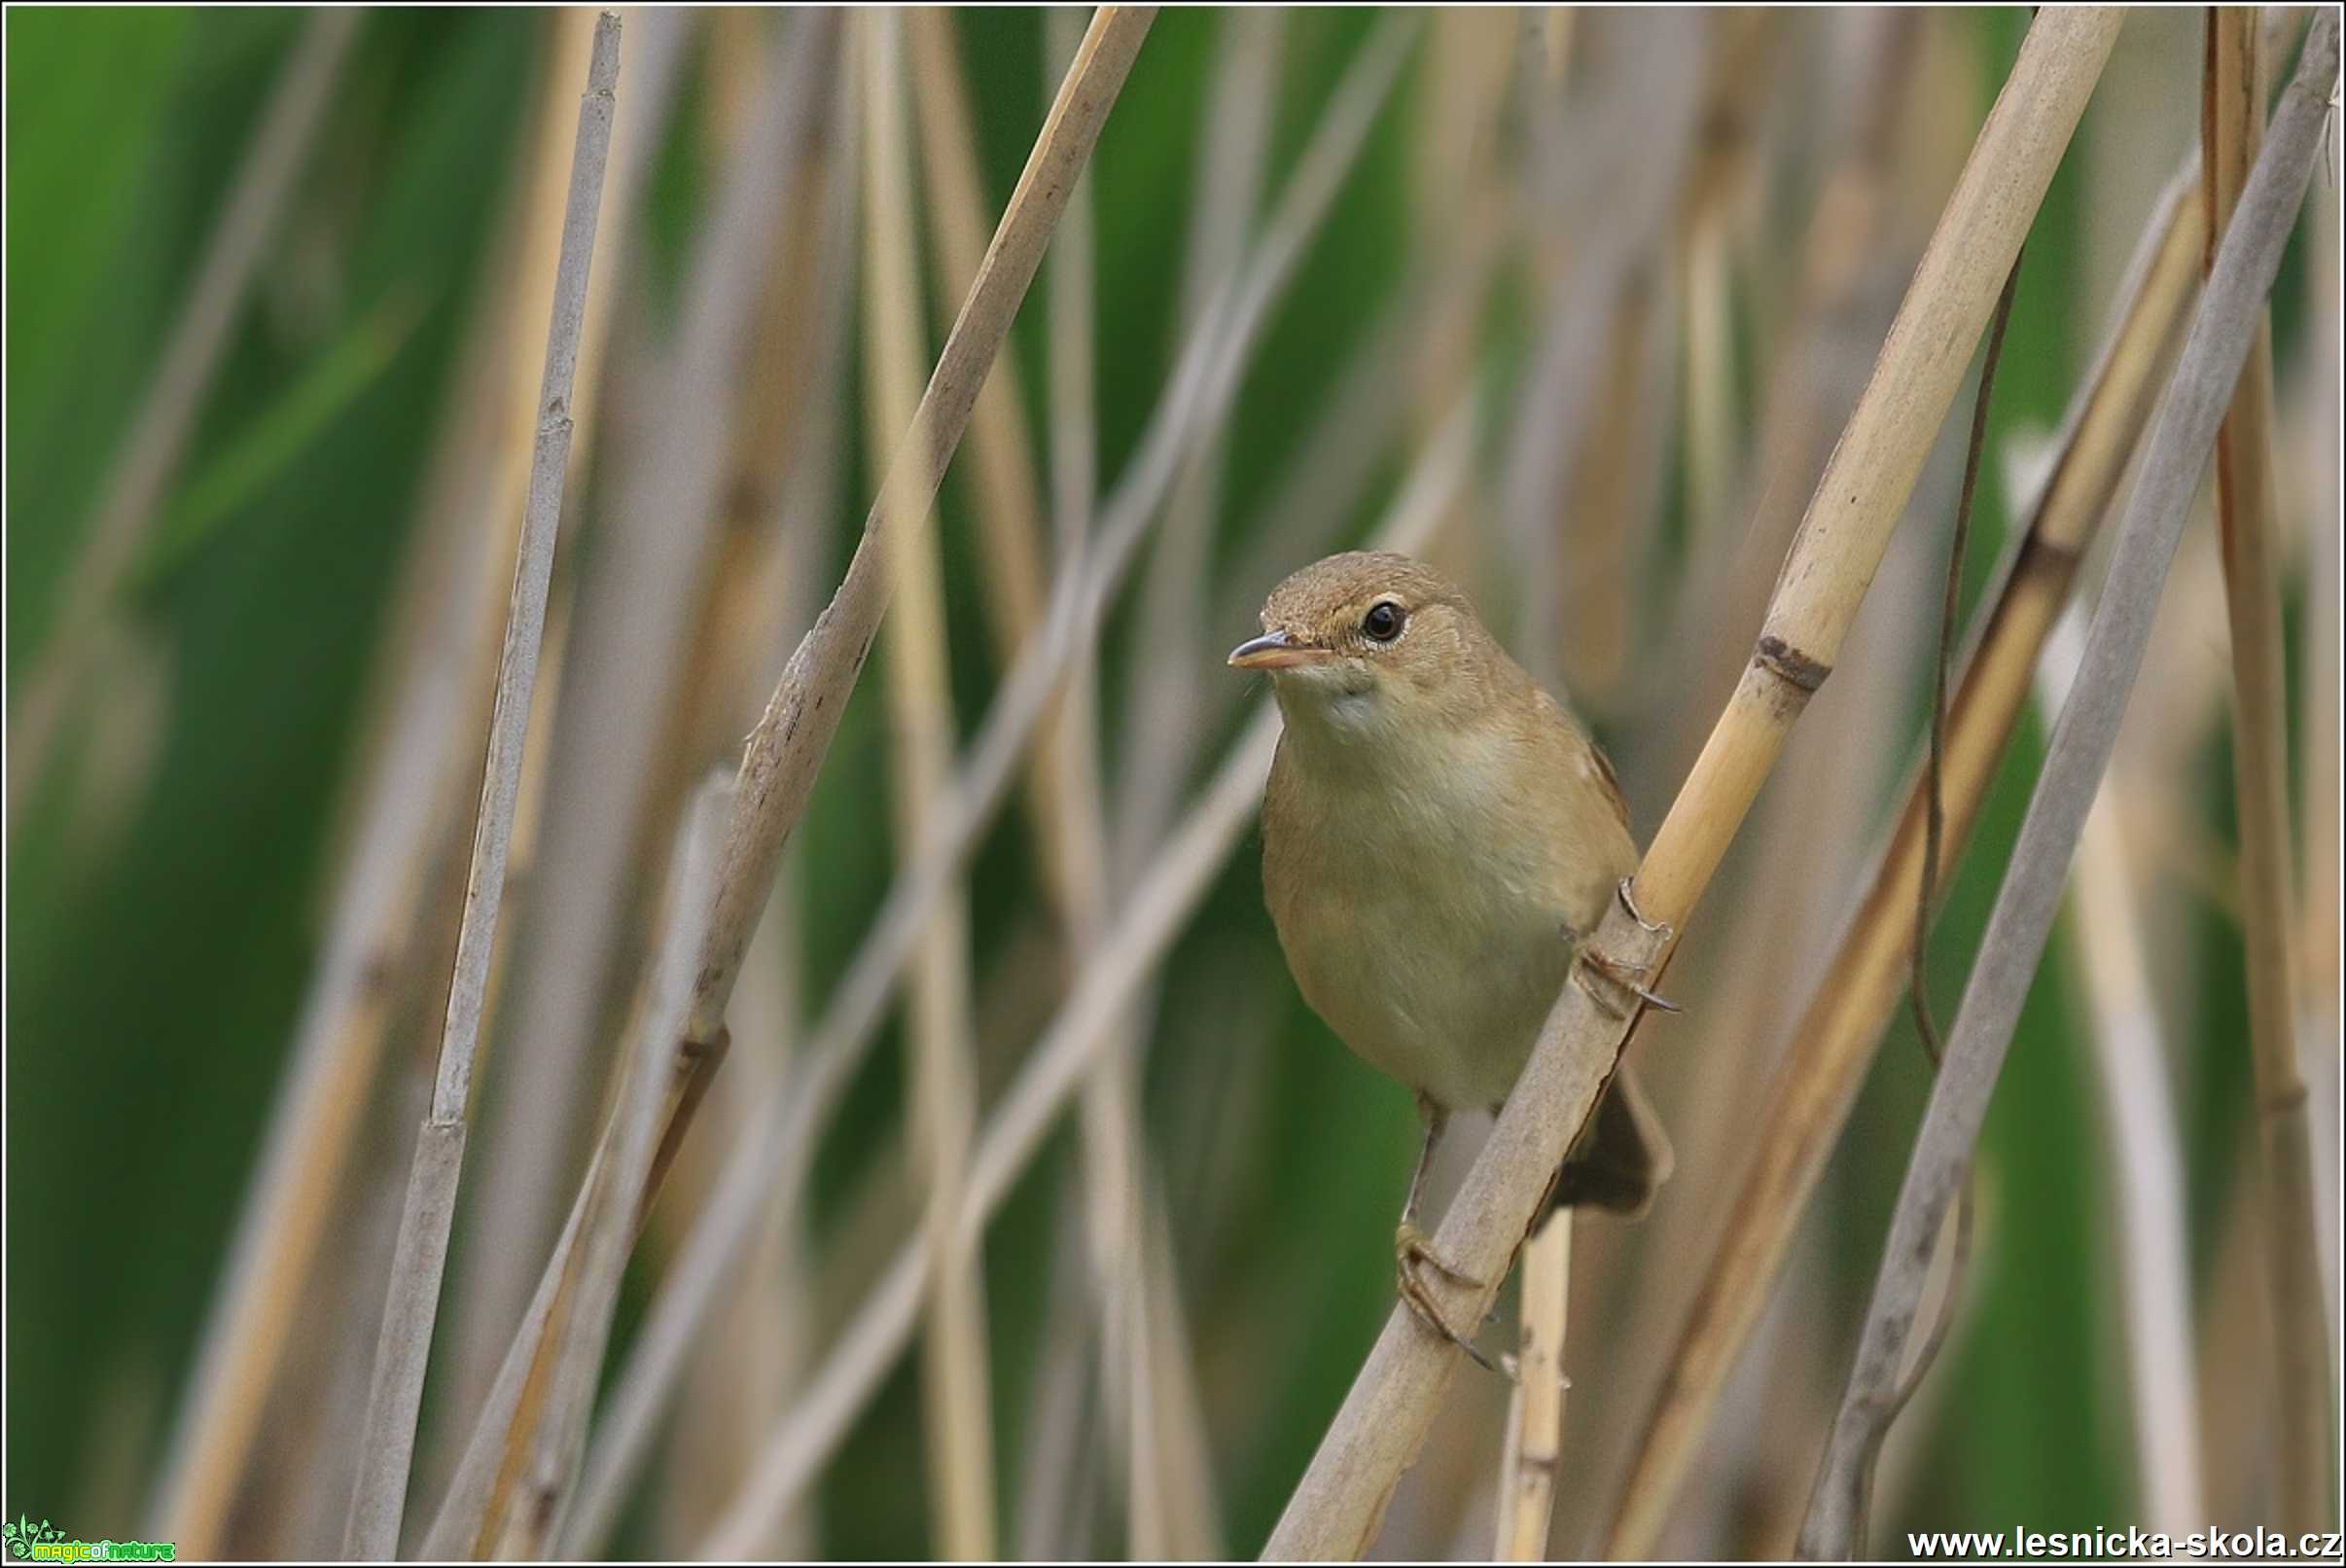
7 10 364 821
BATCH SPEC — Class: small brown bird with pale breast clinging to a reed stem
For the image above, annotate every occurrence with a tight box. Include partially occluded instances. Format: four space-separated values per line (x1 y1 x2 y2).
1229 552 1670 1359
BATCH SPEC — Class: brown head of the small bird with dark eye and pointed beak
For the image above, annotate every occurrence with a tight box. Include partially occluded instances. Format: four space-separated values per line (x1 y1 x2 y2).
1229 552 1497 737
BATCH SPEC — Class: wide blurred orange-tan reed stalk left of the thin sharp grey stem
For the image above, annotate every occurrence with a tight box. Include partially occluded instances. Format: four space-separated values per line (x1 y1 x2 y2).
150 14 676 1556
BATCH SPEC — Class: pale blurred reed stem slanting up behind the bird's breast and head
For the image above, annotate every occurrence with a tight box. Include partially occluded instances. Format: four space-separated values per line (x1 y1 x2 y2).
701 397 1475 1556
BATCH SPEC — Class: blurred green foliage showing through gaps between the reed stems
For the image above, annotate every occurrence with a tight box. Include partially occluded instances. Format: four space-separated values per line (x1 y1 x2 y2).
0 7 2334 1558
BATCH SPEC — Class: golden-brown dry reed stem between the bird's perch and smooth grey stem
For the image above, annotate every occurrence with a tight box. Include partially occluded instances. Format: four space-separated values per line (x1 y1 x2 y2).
1605 152 2198 1558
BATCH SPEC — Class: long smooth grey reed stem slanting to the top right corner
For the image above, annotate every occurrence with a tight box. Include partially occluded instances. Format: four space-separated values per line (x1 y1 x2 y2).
1799 12 2339 1556
